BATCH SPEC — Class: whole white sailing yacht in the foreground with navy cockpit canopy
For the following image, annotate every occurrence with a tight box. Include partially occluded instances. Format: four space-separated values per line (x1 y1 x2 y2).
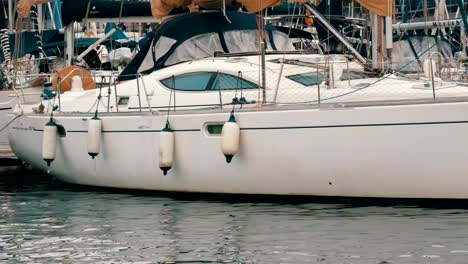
10 11 468 199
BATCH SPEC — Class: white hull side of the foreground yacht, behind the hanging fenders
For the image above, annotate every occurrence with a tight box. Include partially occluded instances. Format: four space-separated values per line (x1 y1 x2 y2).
10 102 468 199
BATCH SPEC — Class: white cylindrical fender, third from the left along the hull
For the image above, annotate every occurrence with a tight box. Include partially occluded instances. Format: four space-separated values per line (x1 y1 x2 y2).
159 121 174 175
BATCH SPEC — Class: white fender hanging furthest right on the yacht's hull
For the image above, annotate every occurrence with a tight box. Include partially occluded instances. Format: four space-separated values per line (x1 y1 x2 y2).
221 111 240 163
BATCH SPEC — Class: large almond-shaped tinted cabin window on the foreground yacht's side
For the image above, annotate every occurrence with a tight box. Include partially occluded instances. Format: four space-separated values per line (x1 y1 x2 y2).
161 72 257 91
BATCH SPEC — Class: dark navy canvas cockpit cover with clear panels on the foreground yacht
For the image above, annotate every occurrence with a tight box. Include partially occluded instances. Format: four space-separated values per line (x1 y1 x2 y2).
119 11 294 81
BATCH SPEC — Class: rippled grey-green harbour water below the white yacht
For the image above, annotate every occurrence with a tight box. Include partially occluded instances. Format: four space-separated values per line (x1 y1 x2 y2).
0 166 468 264
